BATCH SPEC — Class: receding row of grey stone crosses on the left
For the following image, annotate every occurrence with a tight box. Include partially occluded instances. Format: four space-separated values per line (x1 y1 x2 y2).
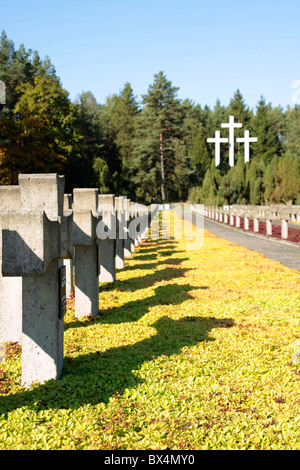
0 174 157 387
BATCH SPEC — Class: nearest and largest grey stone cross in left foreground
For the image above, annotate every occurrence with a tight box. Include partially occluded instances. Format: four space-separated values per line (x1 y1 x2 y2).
0 174 73 387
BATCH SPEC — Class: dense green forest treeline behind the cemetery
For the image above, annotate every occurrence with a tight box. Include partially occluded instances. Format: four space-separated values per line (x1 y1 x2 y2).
0 32 300 205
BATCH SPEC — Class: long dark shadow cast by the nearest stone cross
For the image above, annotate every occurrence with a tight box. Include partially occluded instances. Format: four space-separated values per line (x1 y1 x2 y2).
0 308 233 414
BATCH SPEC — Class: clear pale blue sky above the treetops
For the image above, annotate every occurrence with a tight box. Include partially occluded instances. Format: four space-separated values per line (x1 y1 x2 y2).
0 0 300 108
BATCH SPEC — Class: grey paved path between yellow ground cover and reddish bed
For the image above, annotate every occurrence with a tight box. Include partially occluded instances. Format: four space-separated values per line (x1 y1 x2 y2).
180 211 300 271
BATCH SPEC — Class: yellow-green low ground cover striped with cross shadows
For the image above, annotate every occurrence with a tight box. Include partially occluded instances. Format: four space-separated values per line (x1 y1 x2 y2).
0 211 300 450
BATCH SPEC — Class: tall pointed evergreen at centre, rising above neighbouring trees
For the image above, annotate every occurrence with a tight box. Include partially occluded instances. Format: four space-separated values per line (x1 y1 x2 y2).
133 72 191 201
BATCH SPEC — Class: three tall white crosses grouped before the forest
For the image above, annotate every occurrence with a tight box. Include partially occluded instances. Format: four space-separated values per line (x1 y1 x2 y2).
207 116 257 166
